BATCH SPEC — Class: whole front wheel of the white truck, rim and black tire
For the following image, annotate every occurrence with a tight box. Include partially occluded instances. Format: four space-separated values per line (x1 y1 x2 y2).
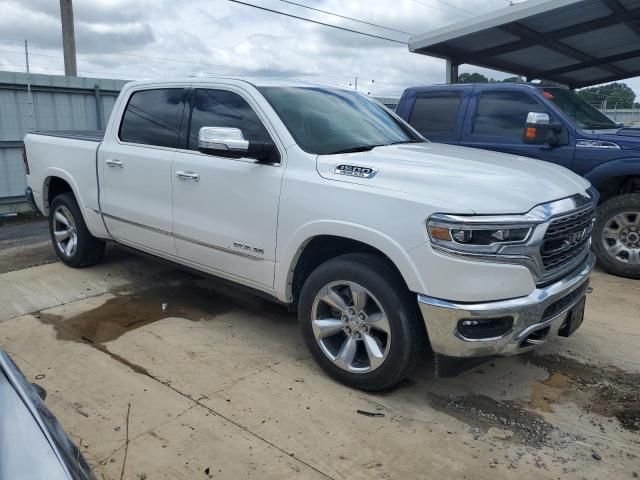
298 254 424 391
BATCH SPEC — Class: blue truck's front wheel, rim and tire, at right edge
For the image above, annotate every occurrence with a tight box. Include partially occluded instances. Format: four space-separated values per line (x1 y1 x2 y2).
593 193 640 278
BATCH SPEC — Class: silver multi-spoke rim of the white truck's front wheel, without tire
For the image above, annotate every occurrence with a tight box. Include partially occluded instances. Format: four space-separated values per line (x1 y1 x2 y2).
311 281 391 373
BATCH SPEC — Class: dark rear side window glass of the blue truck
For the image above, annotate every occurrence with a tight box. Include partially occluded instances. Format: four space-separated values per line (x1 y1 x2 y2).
409 92 462 136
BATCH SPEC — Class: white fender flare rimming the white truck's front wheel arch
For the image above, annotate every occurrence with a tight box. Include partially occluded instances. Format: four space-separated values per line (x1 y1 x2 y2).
274 220 426 302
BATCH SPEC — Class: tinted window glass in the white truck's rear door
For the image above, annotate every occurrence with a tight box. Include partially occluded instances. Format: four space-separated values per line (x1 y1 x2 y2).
119 88 186 148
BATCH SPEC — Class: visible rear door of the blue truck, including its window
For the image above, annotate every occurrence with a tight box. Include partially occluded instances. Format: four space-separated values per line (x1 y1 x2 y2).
398 87 471 144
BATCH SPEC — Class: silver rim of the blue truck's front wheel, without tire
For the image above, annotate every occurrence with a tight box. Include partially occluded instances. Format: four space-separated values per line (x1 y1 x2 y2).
602 212 640 265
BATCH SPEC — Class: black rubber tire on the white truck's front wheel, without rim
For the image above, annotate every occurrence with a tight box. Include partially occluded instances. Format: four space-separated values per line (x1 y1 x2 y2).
298 253 425 391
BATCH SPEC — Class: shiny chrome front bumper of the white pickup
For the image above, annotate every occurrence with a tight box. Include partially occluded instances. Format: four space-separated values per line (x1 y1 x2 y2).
418 252 595 358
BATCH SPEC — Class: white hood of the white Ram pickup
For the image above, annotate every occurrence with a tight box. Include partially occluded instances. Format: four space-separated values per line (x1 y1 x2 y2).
317 143 590 214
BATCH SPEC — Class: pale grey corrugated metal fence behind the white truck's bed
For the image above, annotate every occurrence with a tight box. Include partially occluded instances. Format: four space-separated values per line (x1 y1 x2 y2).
0 72 126 207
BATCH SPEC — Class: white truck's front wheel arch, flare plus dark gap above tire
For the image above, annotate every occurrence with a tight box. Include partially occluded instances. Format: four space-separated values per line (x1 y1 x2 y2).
274 221 425 303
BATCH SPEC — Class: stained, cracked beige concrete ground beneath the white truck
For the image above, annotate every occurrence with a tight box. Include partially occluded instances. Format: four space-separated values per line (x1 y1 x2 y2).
0 246 640 480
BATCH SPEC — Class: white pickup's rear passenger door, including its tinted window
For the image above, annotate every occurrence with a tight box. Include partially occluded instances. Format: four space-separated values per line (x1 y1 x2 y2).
98 88 188 255
